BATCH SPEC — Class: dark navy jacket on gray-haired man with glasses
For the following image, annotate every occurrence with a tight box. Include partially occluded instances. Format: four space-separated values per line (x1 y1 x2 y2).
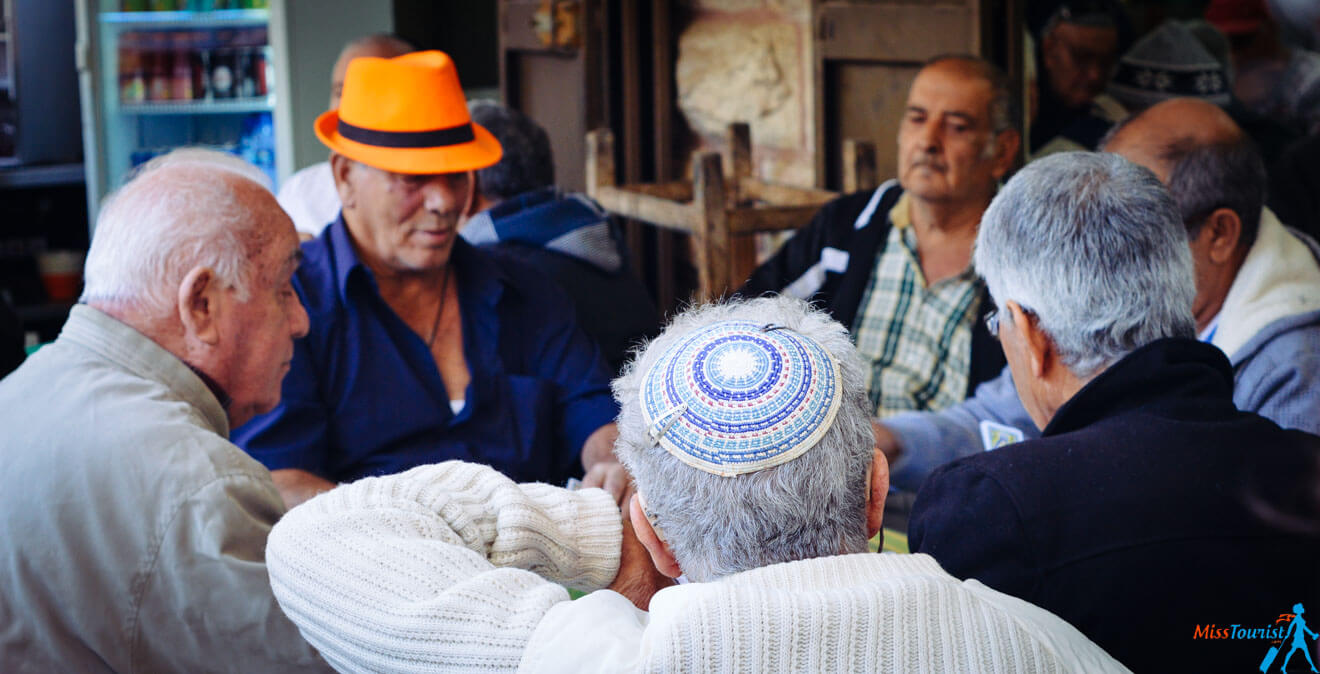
909 339 1320 671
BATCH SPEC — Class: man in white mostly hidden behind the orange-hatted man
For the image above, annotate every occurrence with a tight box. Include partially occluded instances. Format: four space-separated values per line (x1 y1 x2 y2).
279 33 413 239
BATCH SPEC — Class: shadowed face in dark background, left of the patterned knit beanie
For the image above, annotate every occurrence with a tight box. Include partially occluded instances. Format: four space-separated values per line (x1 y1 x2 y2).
1040 22 1118 108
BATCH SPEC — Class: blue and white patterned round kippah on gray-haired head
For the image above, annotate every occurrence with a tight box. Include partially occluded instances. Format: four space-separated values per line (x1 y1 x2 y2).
640 321 842 477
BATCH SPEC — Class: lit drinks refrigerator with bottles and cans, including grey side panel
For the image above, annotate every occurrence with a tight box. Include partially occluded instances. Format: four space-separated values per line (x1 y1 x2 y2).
75 0 393 228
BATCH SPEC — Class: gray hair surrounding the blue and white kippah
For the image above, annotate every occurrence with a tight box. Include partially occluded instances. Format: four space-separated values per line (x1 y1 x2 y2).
614 297 875 582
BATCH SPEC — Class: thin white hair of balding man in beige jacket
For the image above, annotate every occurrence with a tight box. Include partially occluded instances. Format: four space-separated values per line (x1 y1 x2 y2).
81 148 271 318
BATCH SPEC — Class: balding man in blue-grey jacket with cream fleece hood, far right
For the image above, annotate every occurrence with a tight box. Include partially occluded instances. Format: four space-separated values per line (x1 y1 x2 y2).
876 99 1320 491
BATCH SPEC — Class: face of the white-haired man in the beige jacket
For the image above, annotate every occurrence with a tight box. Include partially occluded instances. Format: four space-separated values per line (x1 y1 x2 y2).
215 186 308 427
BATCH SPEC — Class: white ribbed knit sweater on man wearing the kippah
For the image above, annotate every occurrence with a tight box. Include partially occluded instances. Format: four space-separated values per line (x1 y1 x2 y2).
267 462 1126 673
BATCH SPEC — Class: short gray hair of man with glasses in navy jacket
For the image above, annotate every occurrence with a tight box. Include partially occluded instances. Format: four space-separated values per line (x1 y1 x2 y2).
974 152 1196 379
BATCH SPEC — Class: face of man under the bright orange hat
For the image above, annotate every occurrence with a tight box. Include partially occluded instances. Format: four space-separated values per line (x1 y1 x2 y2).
335 157 475 272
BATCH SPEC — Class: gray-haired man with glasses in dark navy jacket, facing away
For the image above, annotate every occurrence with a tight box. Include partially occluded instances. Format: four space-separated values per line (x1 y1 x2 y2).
909 153 1320 671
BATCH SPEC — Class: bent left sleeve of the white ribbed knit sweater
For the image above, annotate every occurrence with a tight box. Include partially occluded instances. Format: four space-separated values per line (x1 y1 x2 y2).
267 462 622 671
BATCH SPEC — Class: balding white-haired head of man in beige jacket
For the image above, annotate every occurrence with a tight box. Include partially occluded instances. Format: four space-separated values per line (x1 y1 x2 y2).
83 149 308 427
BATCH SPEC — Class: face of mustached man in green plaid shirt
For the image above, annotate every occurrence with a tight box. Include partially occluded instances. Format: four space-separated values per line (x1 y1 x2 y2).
899 62 1011 203
